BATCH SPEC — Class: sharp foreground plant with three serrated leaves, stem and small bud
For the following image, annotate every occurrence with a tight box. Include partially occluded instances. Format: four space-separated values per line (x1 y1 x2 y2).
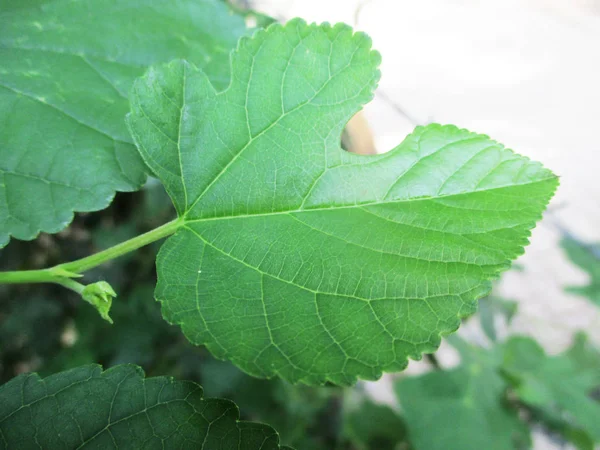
0 0 557 448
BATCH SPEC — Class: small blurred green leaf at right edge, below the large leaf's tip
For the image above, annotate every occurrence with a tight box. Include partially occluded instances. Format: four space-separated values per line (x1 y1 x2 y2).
561 236 600 306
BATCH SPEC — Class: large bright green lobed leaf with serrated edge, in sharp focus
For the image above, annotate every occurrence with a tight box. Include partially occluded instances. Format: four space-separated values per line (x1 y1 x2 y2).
128 20 557 384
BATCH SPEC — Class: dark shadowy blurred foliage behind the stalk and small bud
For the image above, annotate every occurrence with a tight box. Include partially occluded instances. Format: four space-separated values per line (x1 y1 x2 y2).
0 184 351 450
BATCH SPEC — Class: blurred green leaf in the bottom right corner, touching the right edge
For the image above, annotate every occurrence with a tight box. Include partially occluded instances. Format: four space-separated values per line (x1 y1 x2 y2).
503 337 600 442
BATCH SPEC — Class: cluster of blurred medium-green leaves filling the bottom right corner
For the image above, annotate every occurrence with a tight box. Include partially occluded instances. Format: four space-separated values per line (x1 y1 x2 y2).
396 335 600 450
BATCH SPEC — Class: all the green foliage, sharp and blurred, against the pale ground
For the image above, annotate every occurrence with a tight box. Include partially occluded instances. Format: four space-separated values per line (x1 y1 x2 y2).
0 0 600 450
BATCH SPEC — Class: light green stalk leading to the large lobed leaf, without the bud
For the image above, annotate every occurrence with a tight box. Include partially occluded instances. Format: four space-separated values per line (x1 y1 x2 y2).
0 219 184 288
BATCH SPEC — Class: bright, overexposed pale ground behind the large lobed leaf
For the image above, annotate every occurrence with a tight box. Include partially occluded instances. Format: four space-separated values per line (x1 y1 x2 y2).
252 0 600 449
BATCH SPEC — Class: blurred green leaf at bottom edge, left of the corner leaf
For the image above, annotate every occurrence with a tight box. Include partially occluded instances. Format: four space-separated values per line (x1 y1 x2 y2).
395 344 530 450
